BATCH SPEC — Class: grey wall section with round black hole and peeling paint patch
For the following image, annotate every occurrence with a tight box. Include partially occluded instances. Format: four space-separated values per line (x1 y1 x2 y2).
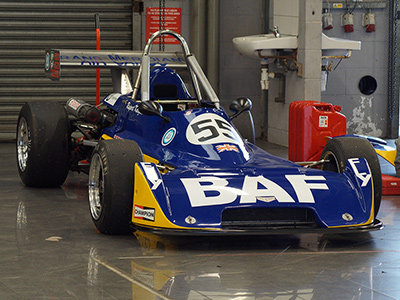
321 7 389 137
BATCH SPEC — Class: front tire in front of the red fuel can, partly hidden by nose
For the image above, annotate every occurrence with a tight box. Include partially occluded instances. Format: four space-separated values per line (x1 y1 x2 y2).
321 137 382 217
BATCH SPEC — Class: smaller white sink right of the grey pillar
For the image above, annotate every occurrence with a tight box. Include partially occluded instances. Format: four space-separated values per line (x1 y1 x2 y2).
321 33 361 56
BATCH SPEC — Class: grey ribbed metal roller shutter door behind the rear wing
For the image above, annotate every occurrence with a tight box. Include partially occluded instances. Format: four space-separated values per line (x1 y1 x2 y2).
0 0 132 141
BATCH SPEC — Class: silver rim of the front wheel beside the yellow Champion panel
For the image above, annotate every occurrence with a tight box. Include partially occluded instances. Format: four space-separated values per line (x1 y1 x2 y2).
89 153 104 220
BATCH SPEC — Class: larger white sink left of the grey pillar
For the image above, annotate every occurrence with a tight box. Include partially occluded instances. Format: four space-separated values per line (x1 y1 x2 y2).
232 33 297 62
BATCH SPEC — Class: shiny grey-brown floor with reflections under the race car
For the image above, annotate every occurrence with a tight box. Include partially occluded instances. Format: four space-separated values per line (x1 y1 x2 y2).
0 143 400 300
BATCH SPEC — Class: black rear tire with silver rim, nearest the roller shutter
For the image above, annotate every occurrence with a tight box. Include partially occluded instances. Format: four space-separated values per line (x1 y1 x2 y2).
16 102 70 187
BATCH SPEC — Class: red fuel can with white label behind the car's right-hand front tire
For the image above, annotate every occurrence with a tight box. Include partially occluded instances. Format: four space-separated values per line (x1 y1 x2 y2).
289 101 346 162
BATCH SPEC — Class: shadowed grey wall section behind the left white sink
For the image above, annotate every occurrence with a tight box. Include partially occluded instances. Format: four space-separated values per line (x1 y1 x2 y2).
219 0 265 138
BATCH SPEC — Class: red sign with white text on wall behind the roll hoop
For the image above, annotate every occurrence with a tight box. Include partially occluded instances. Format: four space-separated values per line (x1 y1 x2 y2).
146 7 181 44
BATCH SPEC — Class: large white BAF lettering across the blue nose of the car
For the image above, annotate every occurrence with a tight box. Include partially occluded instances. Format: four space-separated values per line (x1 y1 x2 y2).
181 175 329 207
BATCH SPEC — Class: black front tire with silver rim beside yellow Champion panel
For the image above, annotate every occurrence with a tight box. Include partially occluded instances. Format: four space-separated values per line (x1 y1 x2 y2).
89 140 144 234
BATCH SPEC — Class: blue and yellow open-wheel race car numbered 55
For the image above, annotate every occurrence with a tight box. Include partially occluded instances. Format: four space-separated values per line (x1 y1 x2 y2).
17 30 382 235
